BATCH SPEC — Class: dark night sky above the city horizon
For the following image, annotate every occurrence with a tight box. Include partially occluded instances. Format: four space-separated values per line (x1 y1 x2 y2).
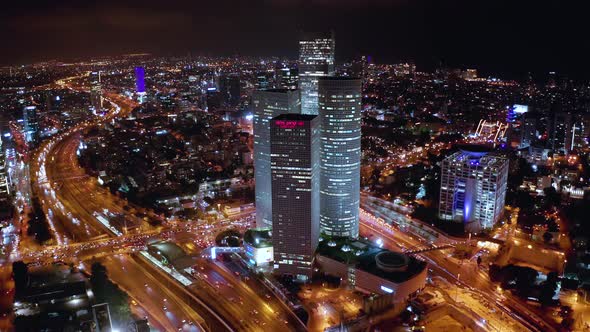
0 0 590 79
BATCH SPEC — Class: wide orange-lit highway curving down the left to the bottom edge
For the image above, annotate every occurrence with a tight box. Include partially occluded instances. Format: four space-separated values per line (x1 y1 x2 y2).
31 74 305 331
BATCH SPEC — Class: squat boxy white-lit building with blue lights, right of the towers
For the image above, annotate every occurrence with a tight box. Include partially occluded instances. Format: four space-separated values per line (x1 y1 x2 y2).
439 145 508 232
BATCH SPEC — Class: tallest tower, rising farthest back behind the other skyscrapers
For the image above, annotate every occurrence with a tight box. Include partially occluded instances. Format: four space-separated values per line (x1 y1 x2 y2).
299 36 335 114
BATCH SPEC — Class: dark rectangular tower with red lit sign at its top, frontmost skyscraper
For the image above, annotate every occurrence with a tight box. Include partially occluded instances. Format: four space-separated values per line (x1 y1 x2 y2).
270 114 320 281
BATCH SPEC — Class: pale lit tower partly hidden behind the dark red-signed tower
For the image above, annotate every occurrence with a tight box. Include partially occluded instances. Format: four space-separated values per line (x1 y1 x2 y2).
252 89 301 227
